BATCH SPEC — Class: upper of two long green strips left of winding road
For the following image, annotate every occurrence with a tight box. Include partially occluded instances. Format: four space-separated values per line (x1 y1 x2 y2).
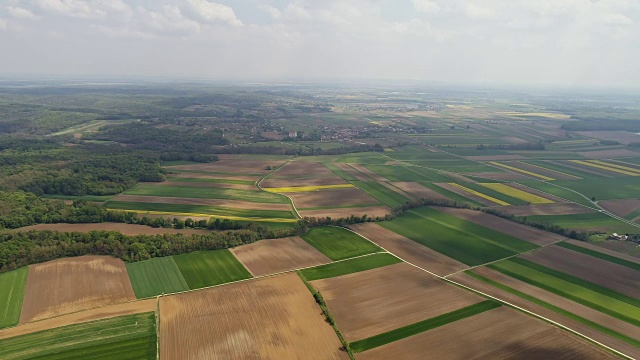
124 183 288 204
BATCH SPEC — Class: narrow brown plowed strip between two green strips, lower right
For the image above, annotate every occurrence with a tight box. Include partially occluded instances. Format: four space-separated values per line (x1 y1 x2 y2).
473 267 640 340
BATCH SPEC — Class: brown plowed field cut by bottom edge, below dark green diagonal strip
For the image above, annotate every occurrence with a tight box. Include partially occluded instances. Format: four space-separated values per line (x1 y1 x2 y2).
357 306 616 360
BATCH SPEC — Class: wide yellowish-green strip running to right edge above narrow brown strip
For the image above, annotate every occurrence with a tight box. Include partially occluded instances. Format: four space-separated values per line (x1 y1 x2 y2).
487 260 640 326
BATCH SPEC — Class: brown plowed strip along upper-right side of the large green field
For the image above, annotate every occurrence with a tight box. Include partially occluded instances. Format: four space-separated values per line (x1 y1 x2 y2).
436 207 567 245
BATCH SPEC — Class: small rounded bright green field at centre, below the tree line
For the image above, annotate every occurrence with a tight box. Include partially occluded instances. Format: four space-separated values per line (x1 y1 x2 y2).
301 227 381 261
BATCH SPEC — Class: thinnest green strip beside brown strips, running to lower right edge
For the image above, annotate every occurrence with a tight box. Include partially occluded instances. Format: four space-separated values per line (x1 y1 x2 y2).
465 270 640 347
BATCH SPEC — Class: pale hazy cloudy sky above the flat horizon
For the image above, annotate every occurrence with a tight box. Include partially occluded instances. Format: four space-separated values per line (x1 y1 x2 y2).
0 0 640 87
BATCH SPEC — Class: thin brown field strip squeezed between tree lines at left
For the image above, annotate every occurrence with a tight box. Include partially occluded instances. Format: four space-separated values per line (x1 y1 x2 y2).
14 223 211 235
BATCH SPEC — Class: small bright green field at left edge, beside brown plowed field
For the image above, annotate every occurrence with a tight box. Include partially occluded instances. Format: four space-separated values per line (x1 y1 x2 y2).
0 266 29 330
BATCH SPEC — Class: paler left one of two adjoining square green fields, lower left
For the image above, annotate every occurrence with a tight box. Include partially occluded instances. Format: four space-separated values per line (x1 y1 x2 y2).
127 256 189 299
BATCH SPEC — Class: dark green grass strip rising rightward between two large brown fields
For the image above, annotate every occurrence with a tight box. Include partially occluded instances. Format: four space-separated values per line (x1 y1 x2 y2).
349 300 502 353
